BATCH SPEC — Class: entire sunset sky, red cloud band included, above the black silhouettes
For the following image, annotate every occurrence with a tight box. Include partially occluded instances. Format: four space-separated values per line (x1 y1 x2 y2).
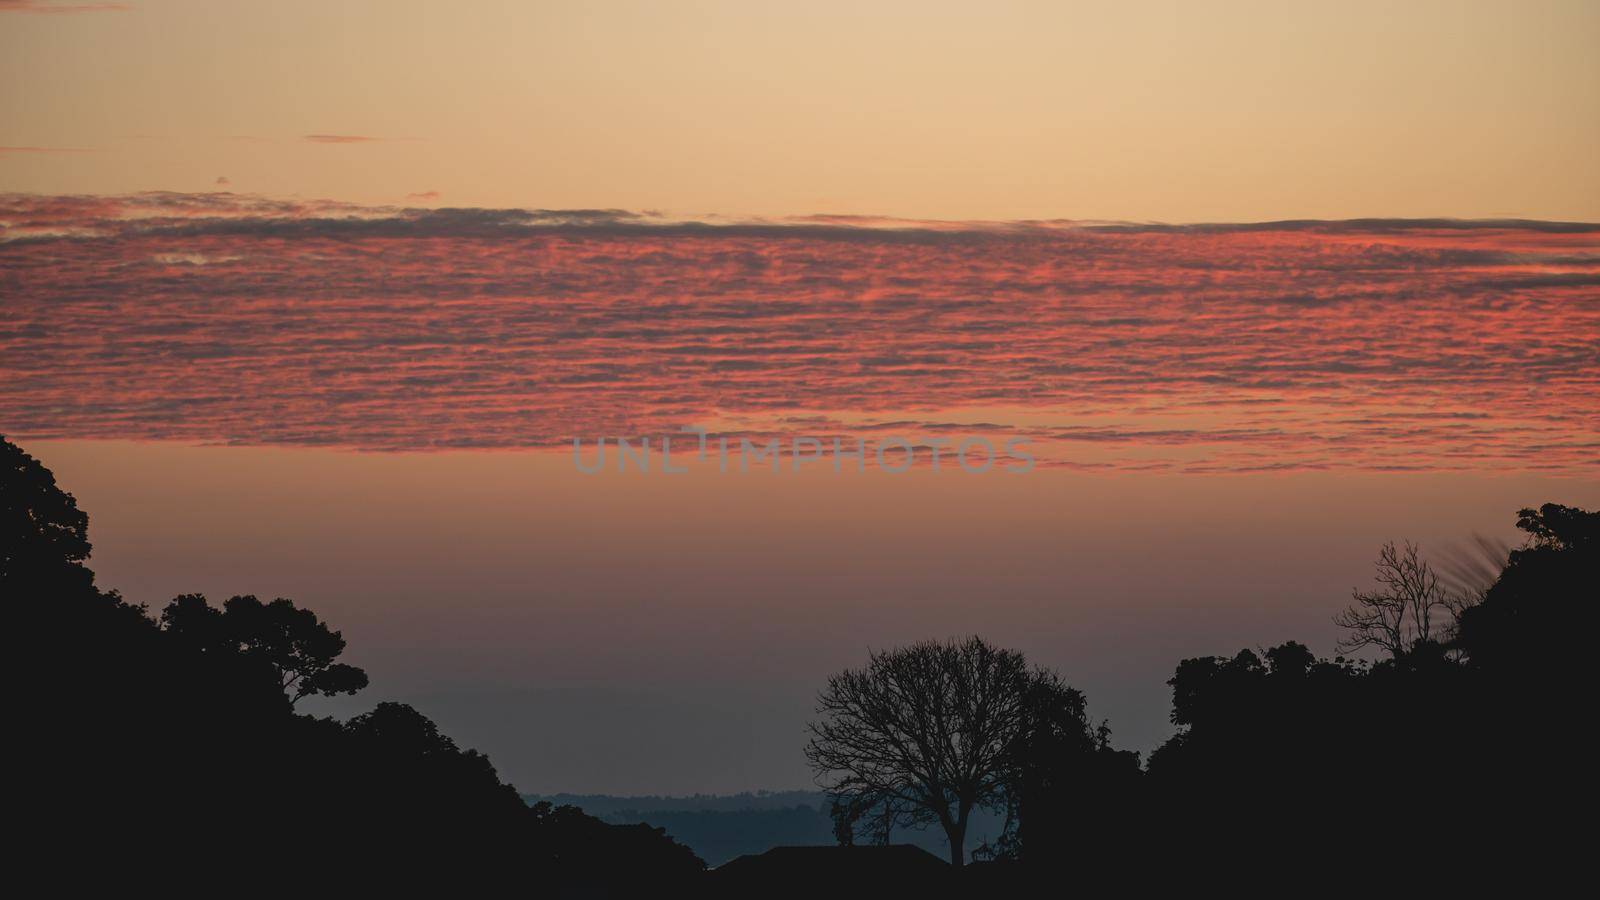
0 0 1600 794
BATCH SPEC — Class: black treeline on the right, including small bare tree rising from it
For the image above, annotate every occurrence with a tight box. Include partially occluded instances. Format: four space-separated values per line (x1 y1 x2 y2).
1126 503 1600 884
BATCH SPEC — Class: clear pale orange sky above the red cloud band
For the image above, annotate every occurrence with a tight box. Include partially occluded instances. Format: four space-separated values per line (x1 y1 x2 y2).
0 0 1600 221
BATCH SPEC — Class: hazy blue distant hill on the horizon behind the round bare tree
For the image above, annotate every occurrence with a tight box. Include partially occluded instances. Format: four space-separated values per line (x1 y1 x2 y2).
523 791 1003 866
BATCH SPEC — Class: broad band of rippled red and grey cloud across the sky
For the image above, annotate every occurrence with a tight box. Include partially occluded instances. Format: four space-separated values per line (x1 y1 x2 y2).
0 194 1600 476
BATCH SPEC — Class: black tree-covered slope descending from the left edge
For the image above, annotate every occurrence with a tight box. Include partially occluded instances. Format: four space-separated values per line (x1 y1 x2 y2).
0 439 704 897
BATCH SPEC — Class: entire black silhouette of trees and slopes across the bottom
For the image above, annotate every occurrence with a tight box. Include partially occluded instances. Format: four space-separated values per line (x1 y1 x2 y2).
9 437 1600 897
